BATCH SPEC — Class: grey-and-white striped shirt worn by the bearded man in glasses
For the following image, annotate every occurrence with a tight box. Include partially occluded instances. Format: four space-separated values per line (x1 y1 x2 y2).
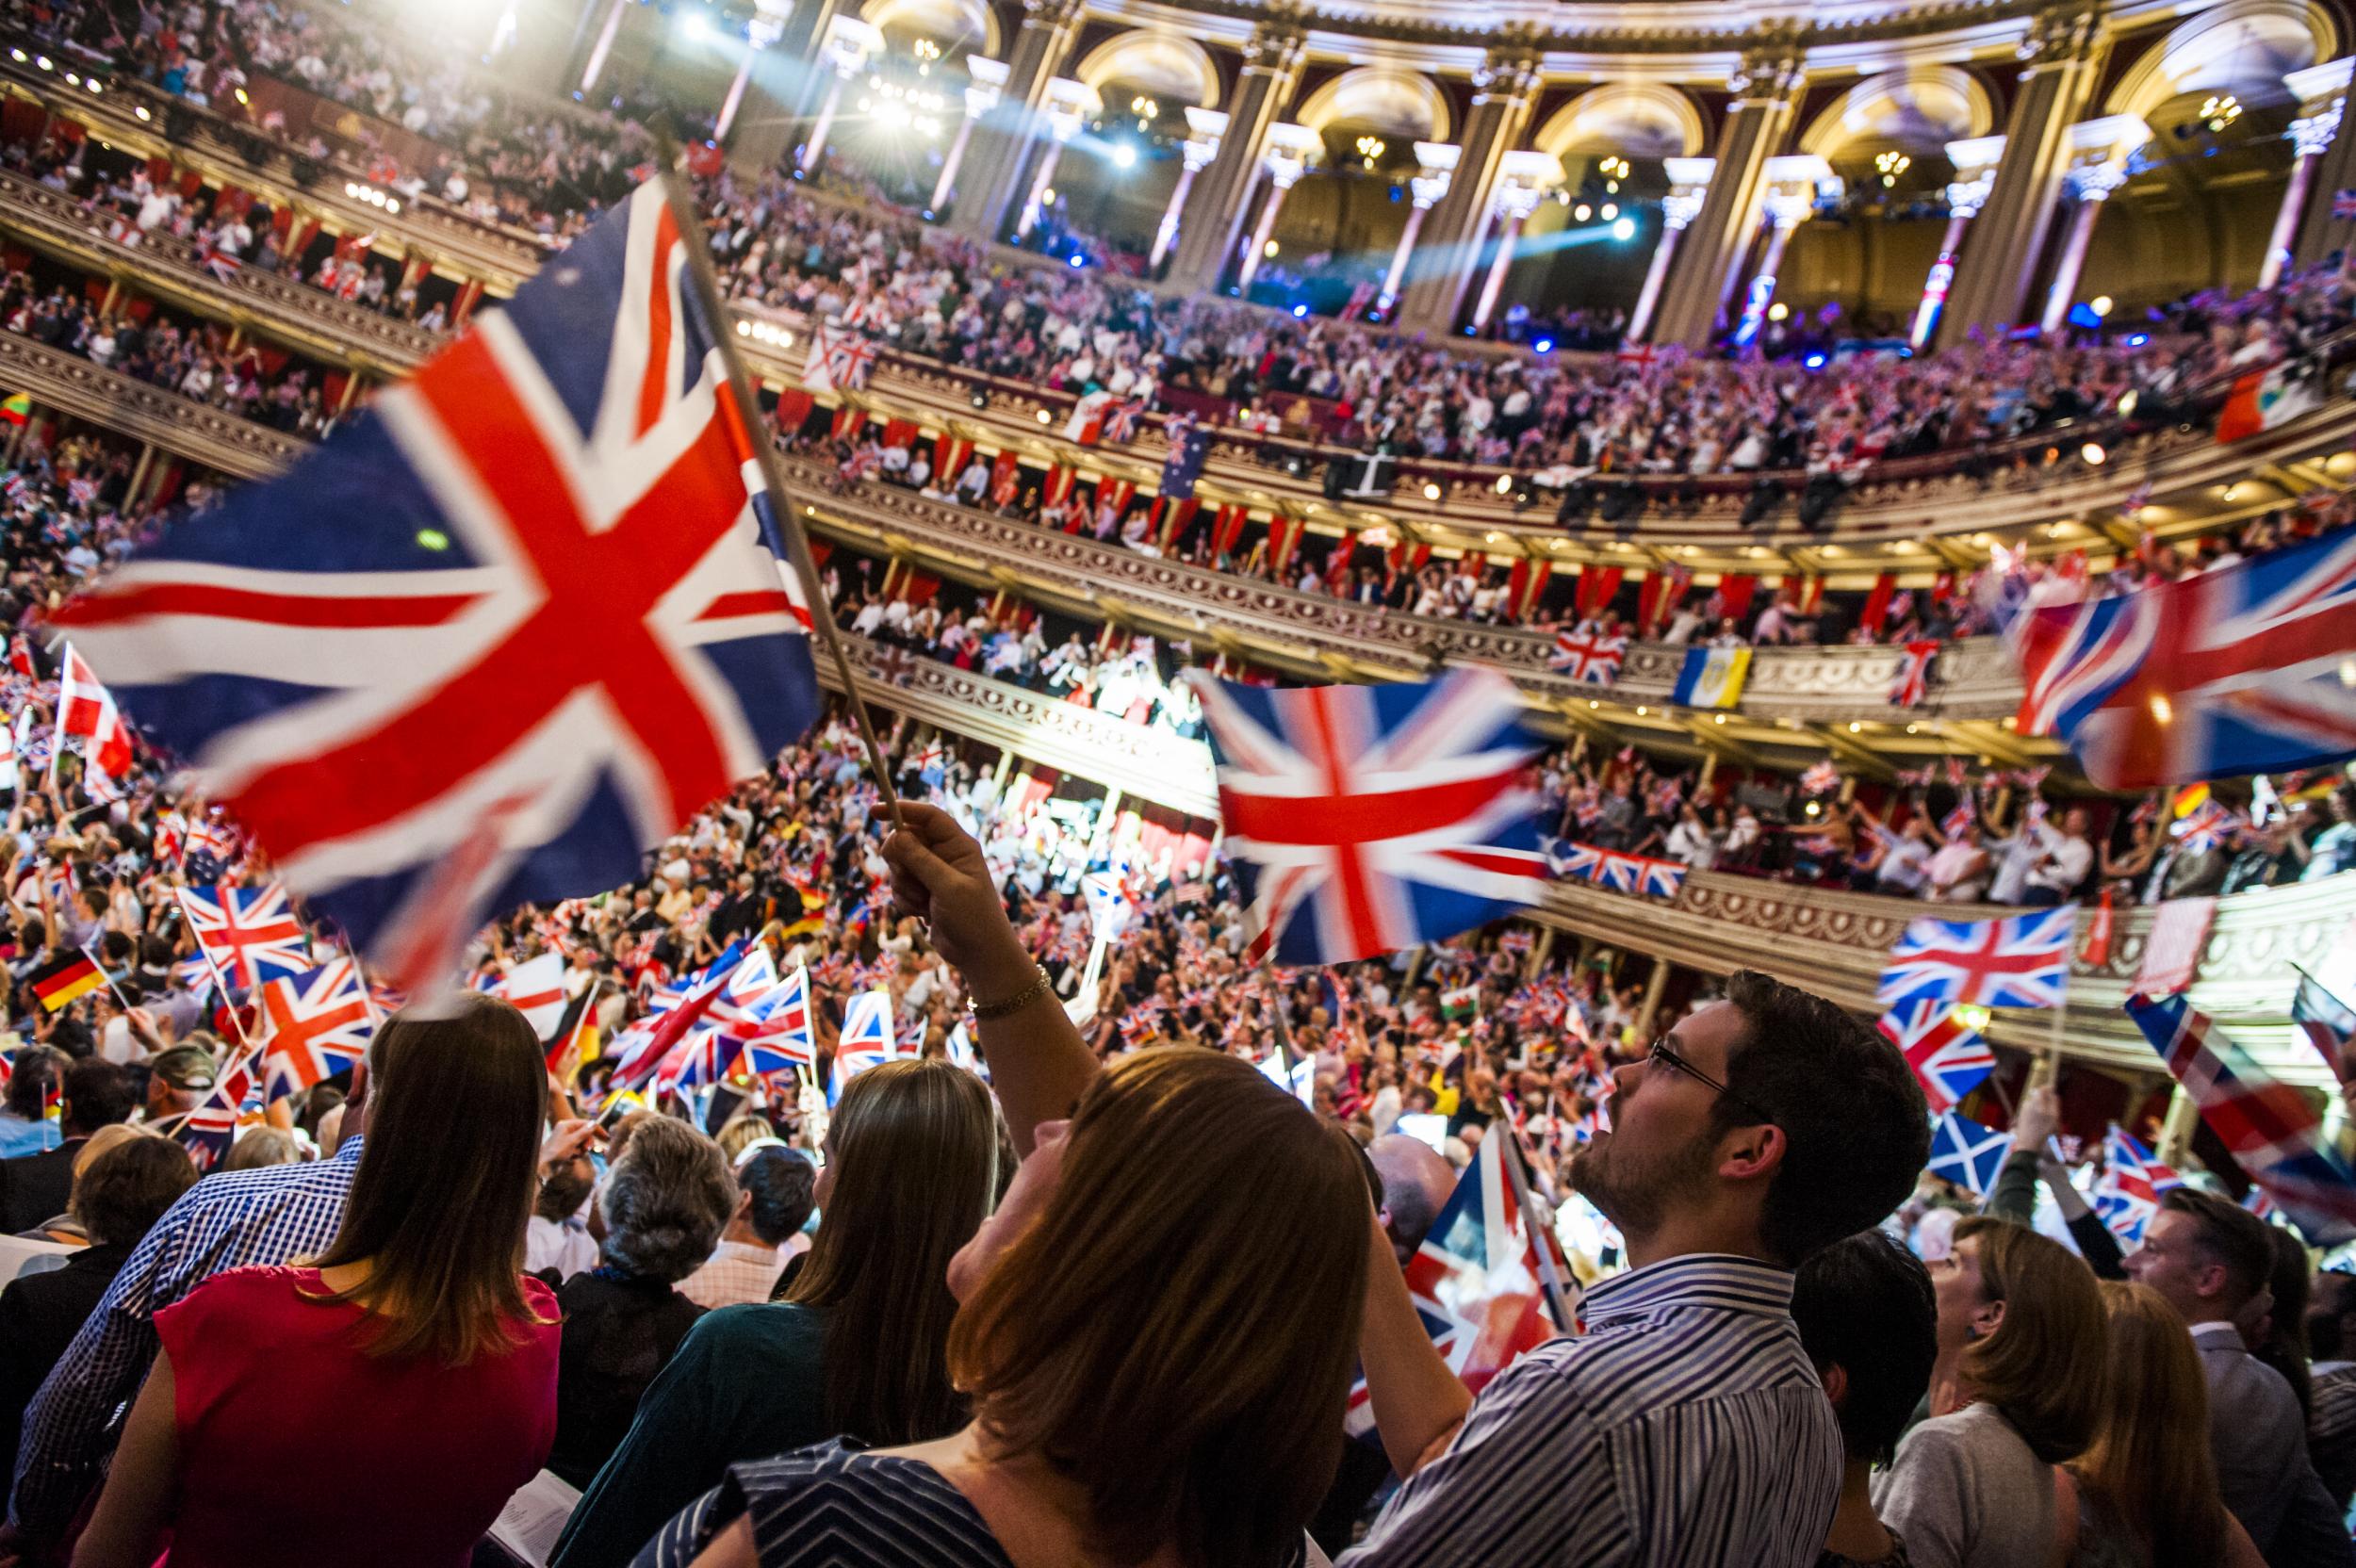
1341 1255 1841 1568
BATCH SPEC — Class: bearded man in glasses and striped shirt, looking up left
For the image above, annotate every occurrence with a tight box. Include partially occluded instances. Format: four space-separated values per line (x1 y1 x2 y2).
1343 970 1930 1568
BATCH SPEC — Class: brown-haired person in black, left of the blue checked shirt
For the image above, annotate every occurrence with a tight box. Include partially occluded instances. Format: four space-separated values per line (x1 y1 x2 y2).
0 1123 196 1477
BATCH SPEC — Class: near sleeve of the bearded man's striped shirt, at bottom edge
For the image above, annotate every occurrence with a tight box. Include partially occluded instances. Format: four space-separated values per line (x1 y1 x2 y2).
1341 1359 1644 1568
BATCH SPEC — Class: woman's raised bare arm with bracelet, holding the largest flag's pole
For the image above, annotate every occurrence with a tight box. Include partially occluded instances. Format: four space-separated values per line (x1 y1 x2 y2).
884 800 1101 1158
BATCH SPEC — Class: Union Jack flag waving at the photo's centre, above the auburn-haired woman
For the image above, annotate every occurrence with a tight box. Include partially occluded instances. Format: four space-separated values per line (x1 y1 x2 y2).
1190 671 1546 963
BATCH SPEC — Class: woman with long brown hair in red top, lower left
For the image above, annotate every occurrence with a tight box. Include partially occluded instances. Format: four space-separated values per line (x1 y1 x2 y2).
74 993 559 1568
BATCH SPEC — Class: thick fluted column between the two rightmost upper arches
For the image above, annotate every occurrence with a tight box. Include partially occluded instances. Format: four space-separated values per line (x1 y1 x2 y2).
1937 0 2109 346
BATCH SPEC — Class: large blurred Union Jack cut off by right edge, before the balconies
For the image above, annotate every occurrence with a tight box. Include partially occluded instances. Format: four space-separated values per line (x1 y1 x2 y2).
2015 530 2356 789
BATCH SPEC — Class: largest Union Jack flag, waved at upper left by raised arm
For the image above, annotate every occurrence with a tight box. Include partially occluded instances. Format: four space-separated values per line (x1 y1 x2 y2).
57 184 820 984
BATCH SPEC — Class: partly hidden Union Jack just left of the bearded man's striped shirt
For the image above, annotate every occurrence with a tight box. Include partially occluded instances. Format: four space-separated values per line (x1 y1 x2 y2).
1348 1135 1577 1434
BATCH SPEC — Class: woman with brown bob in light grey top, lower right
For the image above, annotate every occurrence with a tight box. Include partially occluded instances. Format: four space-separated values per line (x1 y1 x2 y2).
1873 1215 2120 1568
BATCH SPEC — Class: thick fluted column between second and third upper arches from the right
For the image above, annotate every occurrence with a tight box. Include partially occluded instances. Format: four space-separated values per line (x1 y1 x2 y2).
1652 44 1803 349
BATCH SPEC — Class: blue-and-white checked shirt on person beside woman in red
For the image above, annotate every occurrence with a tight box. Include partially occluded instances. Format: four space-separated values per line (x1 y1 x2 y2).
9 1137 361 1540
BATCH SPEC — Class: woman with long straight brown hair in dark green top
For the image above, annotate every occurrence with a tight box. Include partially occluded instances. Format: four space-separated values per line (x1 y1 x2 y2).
551 1062 999 1568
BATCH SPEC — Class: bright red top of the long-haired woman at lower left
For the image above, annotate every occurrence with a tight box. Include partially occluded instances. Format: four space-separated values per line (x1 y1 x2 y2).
155 1269 561 1568
